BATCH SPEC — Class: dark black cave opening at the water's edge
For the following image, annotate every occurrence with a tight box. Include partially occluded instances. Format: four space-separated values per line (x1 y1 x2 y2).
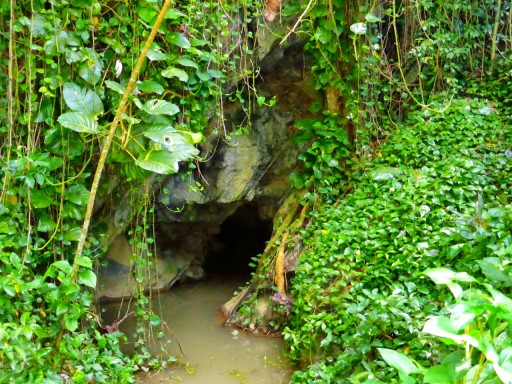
203 202 272 279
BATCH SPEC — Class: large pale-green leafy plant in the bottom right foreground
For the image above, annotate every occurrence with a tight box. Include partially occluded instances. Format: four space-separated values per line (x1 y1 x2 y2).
376 268 512 384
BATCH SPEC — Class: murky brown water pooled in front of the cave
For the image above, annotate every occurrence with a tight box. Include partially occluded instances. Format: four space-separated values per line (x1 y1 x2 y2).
104 279 291 384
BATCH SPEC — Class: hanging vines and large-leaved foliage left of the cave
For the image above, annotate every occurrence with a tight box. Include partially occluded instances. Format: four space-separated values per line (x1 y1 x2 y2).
0 0 254 383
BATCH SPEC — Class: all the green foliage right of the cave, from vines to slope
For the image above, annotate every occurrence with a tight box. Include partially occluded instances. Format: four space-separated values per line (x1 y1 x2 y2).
276 0 512 383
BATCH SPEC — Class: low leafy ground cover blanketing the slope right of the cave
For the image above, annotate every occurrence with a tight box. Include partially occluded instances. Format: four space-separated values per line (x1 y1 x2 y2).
284 98 512 383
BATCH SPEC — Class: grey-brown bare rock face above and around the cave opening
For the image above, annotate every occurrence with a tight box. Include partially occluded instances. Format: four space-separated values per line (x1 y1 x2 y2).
95 32 315 298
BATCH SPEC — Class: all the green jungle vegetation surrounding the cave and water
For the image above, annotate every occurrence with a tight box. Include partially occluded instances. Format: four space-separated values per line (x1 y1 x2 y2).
0 0 512 383
